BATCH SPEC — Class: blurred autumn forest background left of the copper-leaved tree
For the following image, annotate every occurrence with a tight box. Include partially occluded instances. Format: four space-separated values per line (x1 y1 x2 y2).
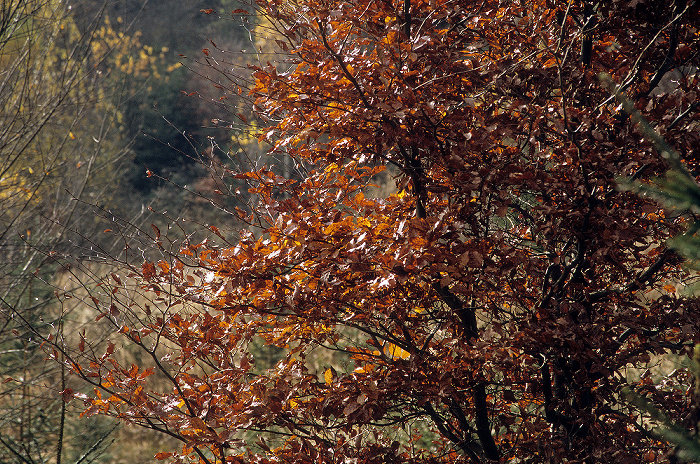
0 0 260 463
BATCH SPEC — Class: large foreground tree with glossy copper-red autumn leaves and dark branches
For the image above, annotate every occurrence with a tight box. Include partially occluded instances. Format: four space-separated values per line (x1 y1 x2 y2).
60 0 700 463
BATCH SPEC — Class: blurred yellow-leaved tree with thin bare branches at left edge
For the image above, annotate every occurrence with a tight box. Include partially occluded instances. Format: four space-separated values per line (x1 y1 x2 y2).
0 0 174 464
